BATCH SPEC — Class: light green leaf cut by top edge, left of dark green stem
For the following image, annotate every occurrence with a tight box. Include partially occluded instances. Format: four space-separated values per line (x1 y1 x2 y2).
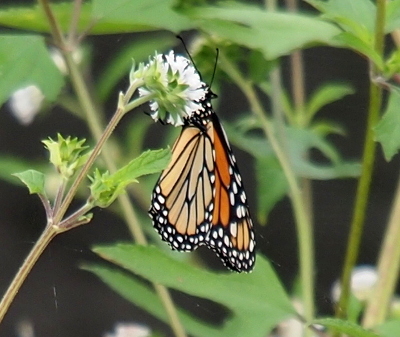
305 0 376 38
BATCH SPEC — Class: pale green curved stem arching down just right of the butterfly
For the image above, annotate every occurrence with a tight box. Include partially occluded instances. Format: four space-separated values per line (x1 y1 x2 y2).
219 52 314 322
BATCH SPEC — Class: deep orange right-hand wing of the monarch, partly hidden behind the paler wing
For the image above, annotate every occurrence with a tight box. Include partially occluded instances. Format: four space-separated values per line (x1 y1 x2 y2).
207 115 255 272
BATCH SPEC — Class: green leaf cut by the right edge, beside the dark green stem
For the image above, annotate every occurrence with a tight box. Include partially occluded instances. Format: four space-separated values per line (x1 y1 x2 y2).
374 89 400 161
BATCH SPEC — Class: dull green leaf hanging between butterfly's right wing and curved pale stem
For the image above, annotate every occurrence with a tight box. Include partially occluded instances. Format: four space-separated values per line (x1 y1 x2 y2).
256 155 288 224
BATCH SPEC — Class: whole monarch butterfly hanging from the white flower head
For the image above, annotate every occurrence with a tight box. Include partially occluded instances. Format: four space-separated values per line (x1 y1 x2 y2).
149 60 255 272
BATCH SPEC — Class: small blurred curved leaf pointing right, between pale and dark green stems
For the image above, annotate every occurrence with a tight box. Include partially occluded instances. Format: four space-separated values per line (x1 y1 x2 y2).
306 83 354 120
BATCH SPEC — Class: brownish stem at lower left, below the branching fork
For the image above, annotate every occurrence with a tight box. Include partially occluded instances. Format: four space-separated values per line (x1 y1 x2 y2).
0 226 57 323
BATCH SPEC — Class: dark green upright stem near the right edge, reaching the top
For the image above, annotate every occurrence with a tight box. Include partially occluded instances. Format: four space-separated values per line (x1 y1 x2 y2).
336 0 386 318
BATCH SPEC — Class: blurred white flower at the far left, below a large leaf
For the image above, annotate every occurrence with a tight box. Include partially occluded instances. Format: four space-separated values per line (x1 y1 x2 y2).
9 85 44 125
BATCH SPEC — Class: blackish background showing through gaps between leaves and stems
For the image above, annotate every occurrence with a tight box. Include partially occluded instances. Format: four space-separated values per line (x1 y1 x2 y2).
0 2 399 337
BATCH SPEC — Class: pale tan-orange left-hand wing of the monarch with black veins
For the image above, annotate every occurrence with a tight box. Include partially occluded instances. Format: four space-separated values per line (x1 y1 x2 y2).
149 126 214 251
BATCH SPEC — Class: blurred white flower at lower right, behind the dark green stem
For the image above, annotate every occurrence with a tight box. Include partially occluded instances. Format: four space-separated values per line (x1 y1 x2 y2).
332 266 378 302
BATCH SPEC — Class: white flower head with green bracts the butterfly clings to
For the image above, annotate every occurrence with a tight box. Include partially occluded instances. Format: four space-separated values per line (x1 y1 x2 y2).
131 51 208 126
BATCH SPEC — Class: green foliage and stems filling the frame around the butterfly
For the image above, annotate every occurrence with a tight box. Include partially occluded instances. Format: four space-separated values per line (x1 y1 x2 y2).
0 0 400 337
